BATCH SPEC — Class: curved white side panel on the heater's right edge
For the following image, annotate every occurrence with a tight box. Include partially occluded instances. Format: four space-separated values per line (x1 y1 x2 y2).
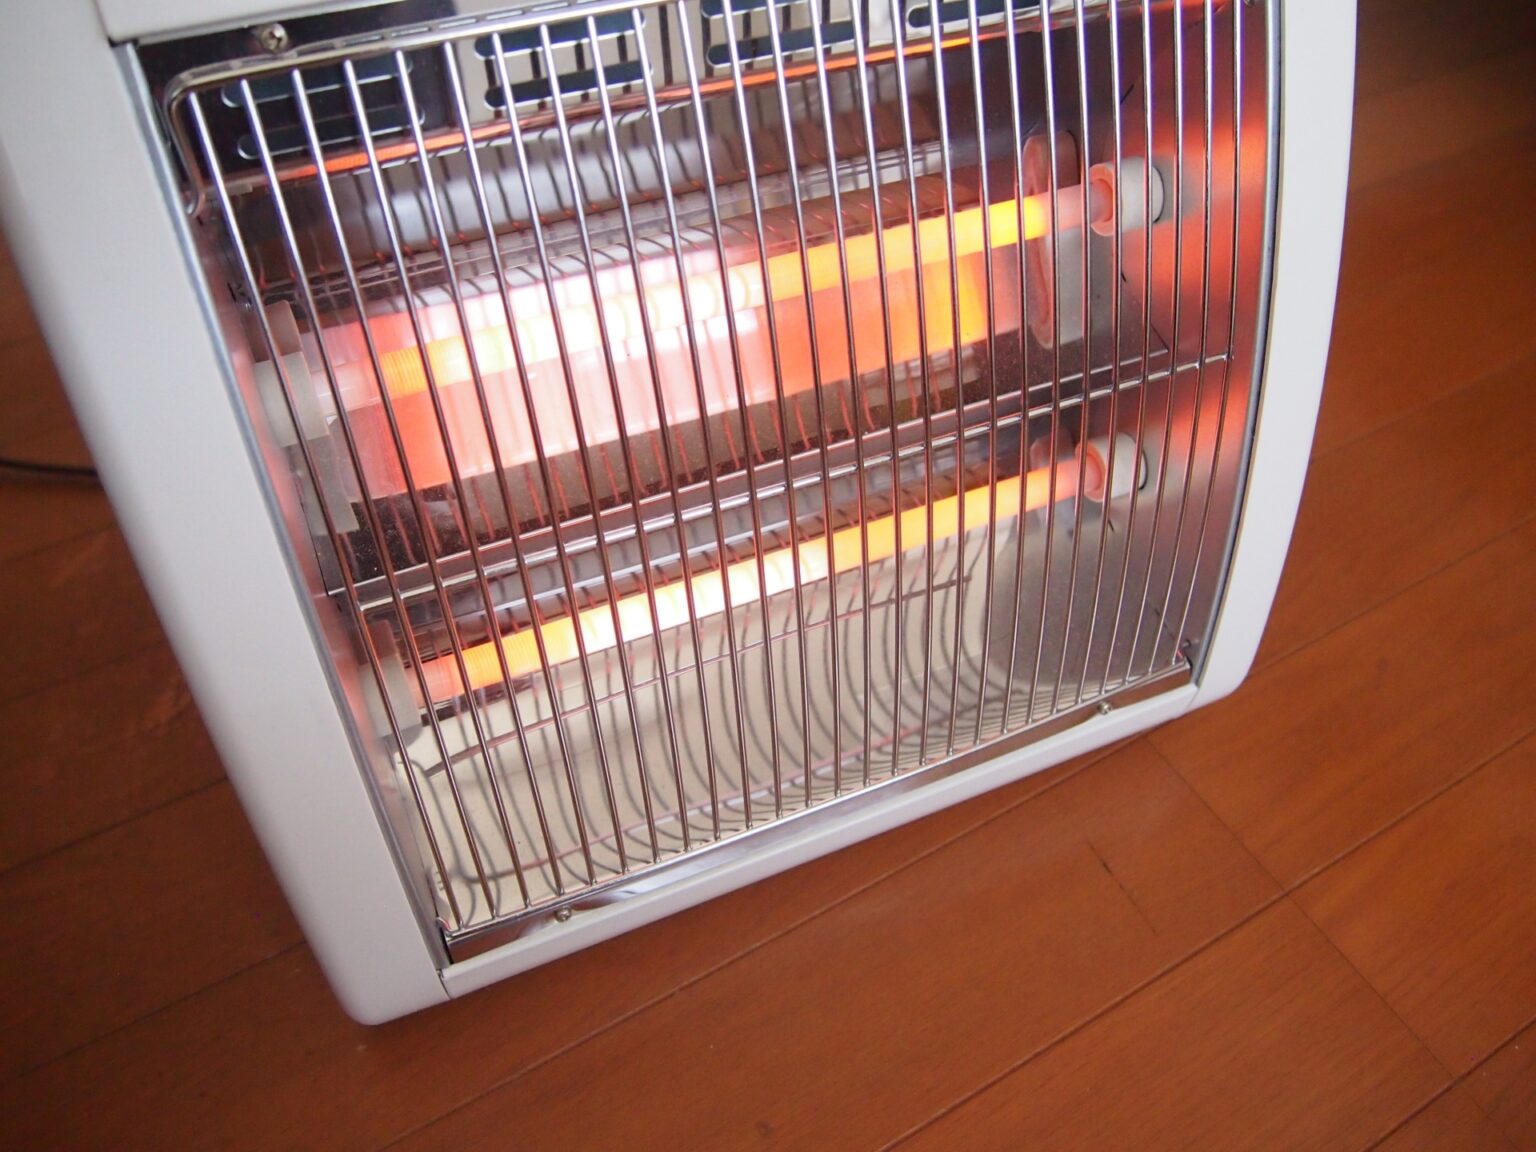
1197 0 1355 703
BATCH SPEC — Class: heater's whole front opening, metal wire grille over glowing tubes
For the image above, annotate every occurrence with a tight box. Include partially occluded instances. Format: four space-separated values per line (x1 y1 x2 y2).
162 0 1273 954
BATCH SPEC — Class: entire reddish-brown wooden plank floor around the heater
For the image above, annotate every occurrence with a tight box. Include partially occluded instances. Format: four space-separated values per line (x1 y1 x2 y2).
0 0 1536 1152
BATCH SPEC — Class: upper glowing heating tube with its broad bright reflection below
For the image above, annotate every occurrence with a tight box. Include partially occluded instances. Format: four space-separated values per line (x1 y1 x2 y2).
305 160 1161 495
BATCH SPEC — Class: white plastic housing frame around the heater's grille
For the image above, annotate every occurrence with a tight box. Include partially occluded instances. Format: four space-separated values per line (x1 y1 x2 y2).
0 0 1355 1021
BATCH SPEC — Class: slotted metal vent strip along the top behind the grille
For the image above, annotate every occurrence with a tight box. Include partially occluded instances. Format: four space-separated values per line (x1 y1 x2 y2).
152 0 1107 206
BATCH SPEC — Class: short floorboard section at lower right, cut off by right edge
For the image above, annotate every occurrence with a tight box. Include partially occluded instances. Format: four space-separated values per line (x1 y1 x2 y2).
1296 737 1536 1075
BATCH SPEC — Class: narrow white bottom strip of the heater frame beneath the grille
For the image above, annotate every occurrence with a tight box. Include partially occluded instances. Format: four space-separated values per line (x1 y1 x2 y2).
442 687 1195 997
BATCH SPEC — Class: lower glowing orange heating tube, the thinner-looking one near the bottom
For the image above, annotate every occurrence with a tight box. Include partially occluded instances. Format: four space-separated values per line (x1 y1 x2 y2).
422 433 1146 702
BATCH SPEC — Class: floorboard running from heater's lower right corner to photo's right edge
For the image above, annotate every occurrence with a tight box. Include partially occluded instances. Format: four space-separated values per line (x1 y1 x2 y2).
1150 522 1536 885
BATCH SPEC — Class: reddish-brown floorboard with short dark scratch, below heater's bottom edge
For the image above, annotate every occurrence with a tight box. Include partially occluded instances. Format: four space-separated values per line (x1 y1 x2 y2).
390 743 1273 1152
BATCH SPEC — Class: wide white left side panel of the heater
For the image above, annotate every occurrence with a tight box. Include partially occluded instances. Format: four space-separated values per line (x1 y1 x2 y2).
0 0 444 1020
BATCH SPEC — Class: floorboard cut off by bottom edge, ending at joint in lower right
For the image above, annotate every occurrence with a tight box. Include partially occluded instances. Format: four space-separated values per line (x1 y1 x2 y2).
900 902 1447 1152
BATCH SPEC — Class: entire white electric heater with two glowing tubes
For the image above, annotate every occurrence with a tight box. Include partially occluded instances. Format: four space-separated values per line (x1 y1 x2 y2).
0 0 1353 1020
